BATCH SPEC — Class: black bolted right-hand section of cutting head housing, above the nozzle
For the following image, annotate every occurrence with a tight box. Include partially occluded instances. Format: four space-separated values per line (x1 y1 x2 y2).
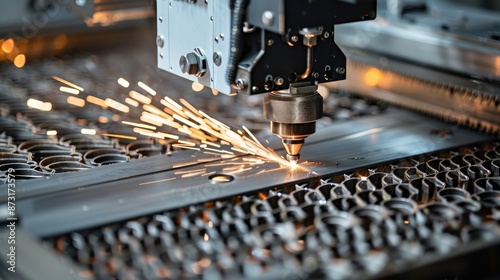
233 1 377 94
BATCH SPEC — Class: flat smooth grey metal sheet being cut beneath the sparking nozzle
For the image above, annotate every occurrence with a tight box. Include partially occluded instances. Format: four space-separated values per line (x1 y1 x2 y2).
18 110 492 236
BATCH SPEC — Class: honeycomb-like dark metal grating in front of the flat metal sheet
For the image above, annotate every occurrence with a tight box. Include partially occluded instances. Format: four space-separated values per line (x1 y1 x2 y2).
37 135 500 279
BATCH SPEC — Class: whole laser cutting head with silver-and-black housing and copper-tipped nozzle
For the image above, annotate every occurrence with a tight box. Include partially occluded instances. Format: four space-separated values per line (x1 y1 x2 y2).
156 0 377 161
